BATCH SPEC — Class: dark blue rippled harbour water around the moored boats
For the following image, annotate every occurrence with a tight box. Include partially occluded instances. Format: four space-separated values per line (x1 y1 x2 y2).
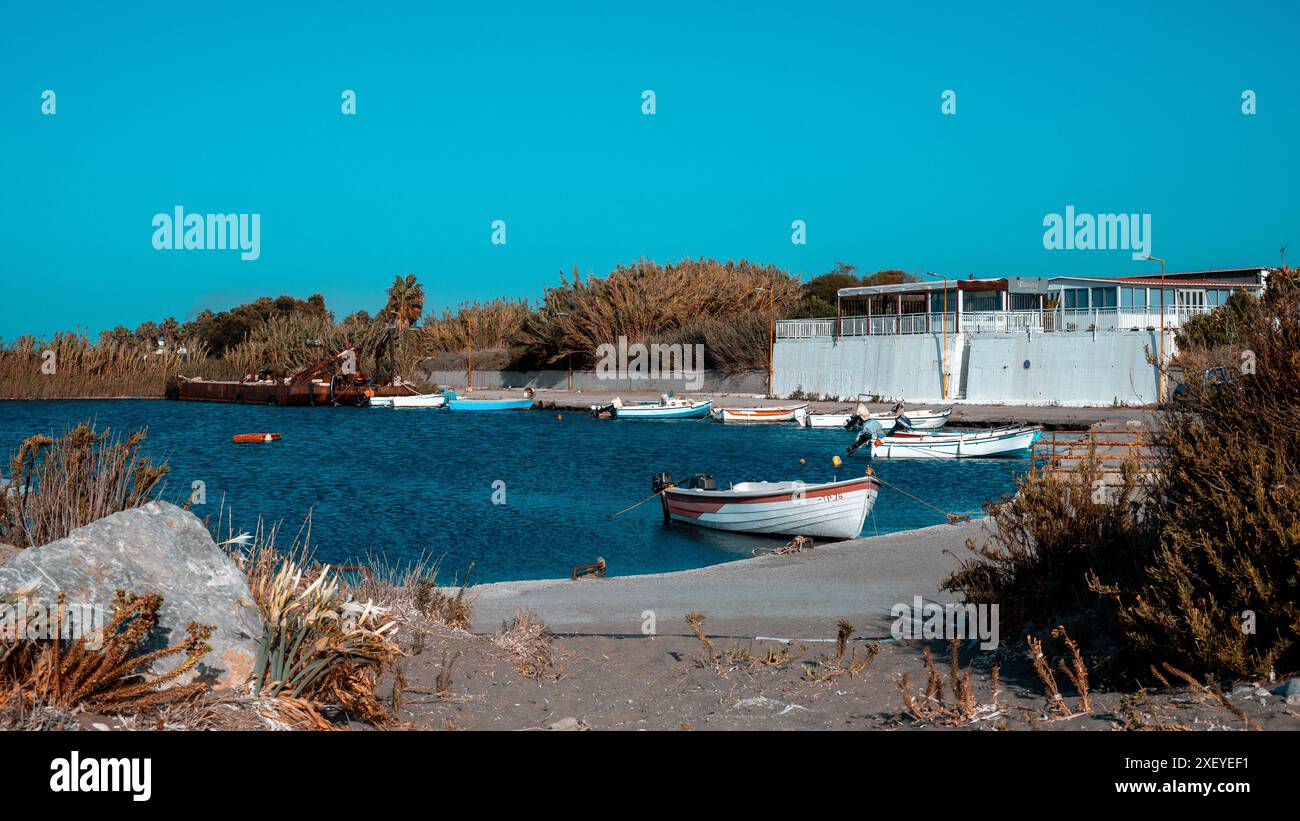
0 400 1028 582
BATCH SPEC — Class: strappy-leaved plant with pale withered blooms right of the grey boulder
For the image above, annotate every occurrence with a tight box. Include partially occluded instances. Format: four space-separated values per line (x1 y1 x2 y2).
218 518 403 726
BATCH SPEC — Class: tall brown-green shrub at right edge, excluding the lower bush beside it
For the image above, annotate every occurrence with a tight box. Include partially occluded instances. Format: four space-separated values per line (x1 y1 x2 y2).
1105 270 1300 678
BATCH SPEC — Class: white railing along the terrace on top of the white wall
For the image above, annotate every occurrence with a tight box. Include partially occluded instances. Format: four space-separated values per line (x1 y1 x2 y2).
776 305 1213 339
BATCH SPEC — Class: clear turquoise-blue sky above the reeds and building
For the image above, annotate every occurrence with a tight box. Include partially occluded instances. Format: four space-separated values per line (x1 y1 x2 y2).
0 0 1300 339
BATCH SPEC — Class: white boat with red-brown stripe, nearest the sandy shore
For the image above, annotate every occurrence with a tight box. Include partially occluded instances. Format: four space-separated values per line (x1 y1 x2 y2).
654 474 880 539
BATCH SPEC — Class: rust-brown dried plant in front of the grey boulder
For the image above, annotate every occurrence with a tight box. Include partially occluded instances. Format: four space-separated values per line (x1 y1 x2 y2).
0 591 213 713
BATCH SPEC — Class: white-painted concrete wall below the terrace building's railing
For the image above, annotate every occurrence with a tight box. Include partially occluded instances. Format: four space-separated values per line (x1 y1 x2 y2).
774 331 1173 407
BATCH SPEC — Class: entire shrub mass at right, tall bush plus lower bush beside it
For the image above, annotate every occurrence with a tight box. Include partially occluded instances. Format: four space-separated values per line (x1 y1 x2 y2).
944 270 1300 678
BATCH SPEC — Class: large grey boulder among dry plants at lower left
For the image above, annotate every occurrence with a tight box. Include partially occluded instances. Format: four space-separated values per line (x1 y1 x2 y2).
0 501 263 687
